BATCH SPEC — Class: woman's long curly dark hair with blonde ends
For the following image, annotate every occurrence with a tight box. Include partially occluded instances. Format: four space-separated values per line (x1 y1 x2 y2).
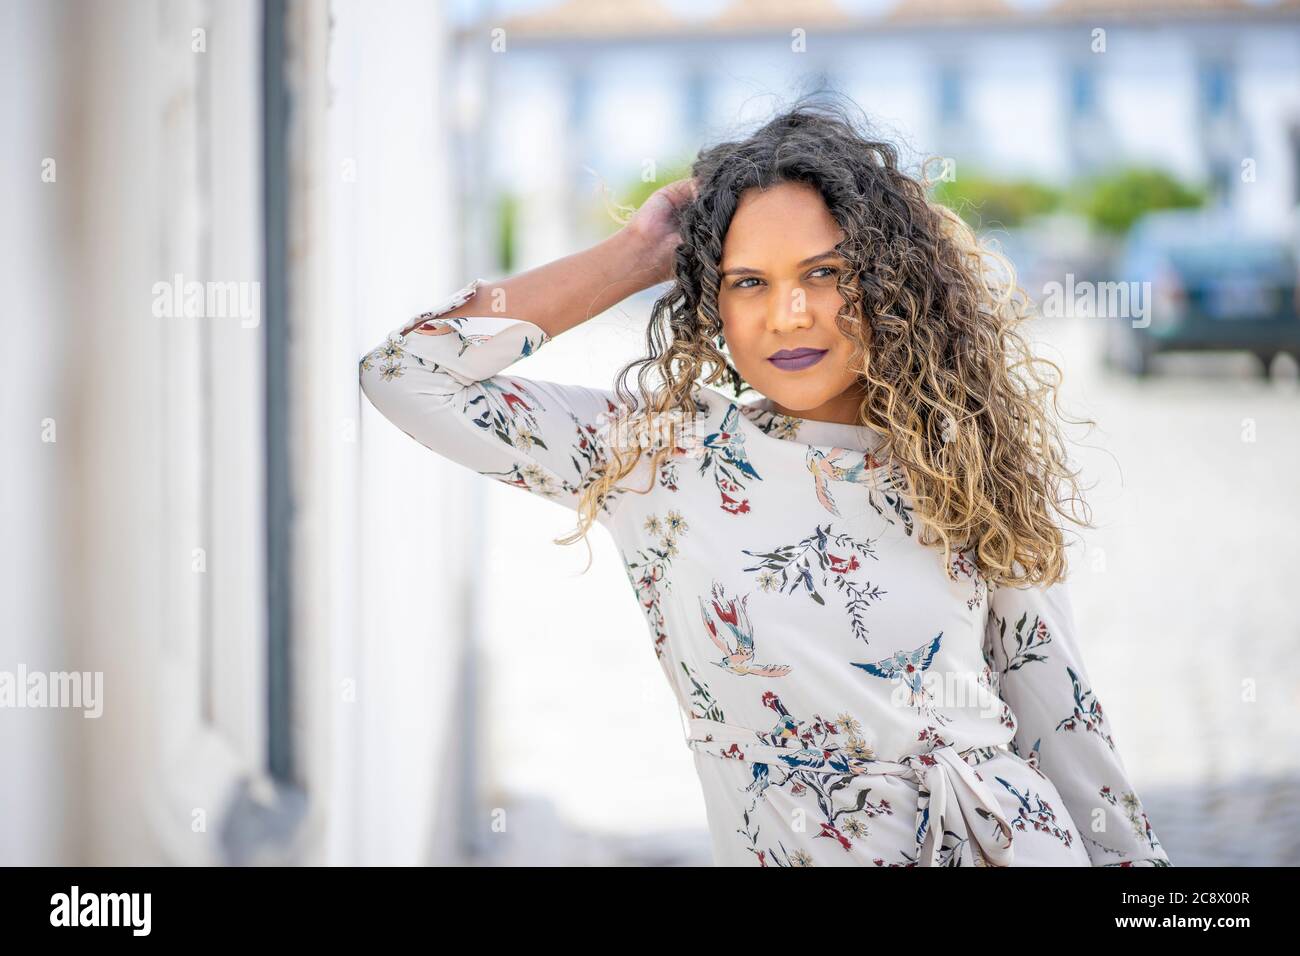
556 101 1096 587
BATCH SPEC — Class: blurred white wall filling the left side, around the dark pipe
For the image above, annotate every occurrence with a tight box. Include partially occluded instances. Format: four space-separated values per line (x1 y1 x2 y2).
0 0 475 865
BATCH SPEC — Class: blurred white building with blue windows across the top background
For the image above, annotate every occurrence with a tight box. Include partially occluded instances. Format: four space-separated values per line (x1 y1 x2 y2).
456 0 1300 261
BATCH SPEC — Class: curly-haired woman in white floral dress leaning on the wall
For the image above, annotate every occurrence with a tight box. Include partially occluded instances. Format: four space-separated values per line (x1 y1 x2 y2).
360 104 1169 866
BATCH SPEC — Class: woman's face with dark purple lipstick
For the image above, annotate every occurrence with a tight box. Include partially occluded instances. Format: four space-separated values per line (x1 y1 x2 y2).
718 182 862 424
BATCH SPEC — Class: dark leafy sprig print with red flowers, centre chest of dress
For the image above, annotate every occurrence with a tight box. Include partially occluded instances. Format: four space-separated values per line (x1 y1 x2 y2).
742 524 888 643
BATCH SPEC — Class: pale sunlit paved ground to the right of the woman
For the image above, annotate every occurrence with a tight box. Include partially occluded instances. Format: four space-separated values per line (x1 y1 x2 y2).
1041 320 1300 866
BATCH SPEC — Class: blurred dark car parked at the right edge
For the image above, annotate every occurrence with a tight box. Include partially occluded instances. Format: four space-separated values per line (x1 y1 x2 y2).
1106 209 1300 376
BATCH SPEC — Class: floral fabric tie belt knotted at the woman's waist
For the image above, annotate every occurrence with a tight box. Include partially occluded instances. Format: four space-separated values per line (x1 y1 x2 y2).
686 718 1013 866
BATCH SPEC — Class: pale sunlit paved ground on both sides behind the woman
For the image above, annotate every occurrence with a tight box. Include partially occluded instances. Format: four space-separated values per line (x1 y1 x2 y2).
482 306 1300 866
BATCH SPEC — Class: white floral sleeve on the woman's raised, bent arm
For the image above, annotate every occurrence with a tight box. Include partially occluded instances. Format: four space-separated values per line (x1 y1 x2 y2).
359 278 631 524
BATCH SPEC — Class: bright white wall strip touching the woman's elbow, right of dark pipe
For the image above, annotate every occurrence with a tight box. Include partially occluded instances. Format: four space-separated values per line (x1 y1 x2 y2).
330 0 477 864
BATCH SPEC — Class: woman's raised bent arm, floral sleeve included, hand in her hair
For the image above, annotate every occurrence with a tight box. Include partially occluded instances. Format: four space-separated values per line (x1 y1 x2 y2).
359 181 702 522
